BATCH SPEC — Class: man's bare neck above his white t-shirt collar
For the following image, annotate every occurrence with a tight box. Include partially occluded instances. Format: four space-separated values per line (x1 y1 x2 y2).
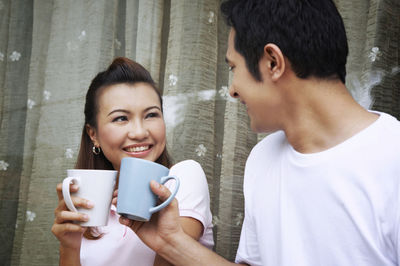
283 80 378 153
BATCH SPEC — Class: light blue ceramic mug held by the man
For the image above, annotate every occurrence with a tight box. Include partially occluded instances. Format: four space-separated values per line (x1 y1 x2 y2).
117 157 179 222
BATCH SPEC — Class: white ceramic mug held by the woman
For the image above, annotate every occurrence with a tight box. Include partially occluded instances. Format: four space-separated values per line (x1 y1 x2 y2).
62 169 118 226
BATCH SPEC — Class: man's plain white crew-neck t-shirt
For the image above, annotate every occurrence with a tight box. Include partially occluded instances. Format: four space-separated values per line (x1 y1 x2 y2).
236 113 400 266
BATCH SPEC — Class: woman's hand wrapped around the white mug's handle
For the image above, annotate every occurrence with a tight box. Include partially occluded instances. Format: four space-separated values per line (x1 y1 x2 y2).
51 184 93 251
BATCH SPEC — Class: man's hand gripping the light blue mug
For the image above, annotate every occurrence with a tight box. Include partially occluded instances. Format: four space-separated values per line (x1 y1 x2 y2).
119 181 184 253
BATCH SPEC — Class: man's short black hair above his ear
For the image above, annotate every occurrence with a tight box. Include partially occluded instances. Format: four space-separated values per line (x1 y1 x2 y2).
221 0 348 83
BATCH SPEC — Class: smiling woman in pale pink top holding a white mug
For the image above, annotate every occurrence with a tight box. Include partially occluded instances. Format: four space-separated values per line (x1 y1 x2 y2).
52 58 213 266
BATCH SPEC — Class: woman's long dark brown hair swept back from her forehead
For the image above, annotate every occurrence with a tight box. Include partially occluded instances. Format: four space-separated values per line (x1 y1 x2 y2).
75 57 172 239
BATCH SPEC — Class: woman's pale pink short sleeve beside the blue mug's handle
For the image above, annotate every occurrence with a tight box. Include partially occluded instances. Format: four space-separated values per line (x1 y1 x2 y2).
165 160 212 231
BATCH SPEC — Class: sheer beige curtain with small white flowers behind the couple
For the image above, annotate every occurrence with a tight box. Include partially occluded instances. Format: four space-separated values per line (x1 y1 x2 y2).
0 0 400 265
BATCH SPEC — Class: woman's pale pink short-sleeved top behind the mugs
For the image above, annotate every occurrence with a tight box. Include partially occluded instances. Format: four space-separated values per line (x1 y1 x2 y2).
81 160 214 266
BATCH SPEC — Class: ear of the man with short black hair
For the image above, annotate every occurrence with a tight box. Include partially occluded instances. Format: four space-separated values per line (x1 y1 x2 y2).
263 43 286 81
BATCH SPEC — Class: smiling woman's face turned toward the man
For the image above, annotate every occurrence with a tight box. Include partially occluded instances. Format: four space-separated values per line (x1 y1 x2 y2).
86 82 168 170
